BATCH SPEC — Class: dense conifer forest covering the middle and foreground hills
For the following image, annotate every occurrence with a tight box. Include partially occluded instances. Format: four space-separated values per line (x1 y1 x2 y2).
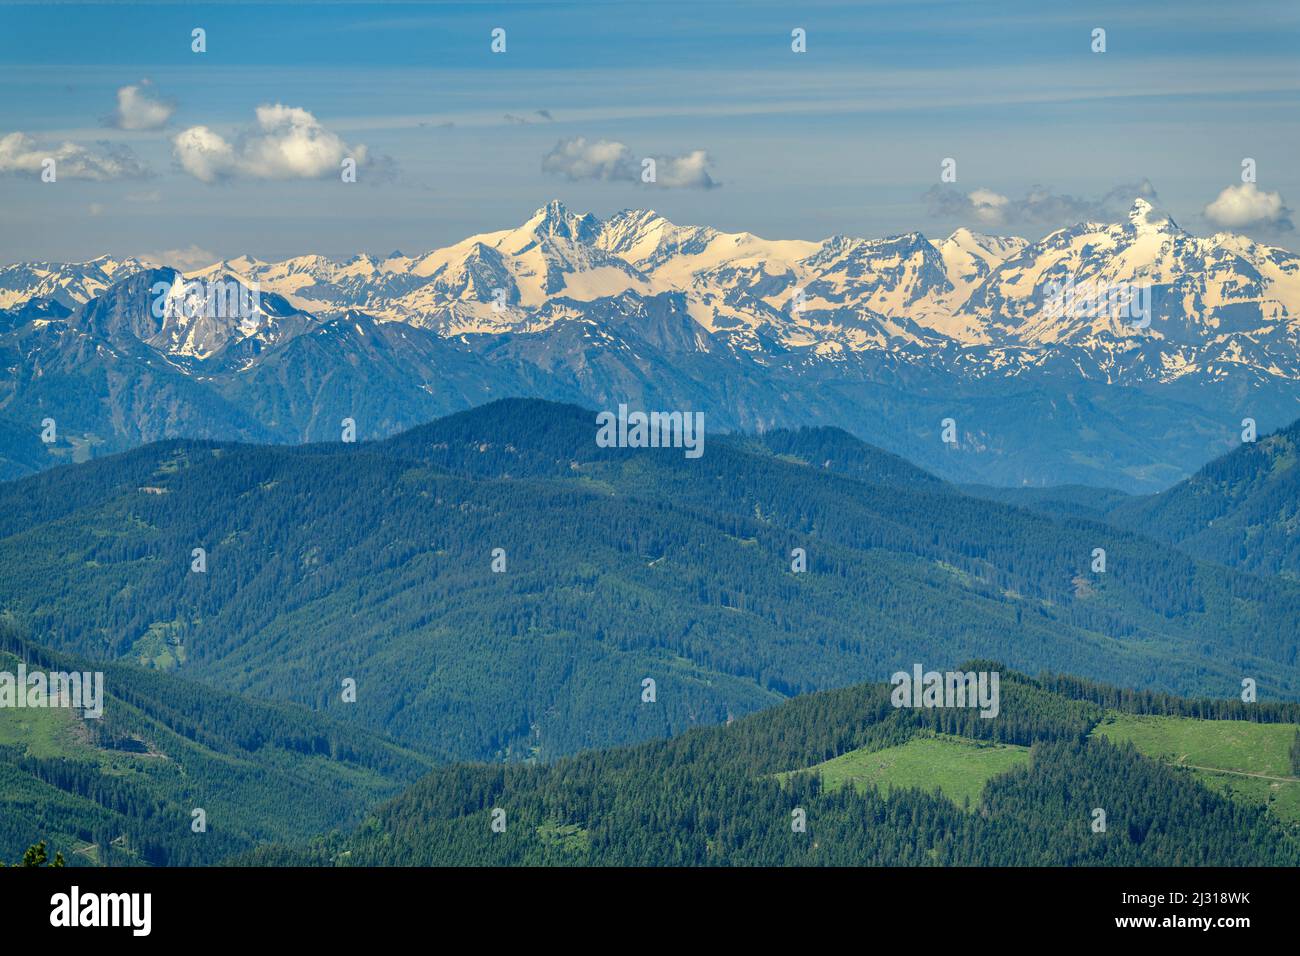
0 401 1300 865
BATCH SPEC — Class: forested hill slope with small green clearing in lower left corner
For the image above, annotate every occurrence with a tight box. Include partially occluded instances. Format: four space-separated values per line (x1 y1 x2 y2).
0 620 428 866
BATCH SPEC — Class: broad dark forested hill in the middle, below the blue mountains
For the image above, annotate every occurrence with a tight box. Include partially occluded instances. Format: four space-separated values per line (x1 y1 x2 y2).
0 401 1300 760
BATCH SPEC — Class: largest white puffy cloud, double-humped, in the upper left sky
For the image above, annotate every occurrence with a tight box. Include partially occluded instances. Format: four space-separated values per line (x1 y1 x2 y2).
172 103 368 182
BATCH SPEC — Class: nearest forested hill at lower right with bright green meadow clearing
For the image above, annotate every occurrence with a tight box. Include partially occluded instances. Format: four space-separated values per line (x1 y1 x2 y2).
239 662 1300 866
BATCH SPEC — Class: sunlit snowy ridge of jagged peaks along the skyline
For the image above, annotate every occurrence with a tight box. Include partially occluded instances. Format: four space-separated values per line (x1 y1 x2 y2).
10 198 1300 361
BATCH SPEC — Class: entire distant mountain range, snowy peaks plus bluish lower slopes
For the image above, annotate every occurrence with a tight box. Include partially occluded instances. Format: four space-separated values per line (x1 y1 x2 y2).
0 199 1300 486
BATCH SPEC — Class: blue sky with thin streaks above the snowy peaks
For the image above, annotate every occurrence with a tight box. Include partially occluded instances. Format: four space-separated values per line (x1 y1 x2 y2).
0 0 1300 261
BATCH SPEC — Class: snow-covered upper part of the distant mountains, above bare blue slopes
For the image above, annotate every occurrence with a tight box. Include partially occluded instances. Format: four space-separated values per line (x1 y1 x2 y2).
10 199 1300 381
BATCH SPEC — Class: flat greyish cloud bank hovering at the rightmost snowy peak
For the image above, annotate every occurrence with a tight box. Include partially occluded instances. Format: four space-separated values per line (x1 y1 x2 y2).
922 179 1156 226
